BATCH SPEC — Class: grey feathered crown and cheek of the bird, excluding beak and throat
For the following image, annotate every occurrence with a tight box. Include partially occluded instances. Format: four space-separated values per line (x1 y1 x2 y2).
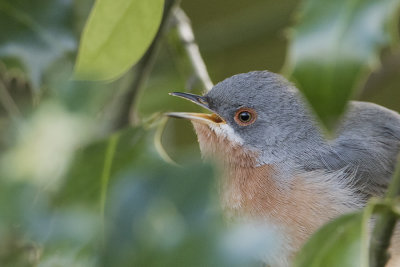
204 71 325 164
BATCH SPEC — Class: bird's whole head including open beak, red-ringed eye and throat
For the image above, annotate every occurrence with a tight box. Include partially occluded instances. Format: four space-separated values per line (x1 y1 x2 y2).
168 71 321 168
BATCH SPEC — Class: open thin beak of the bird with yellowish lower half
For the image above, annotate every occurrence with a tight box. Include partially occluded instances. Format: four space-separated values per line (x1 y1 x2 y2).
166 92 225 124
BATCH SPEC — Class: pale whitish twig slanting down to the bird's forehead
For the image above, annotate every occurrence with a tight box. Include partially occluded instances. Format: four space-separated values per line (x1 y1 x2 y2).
174 7 213 91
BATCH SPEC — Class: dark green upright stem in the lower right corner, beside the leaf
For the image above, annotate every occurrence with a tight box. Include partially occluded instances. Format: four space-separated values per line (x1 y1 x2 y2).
370 156 400 267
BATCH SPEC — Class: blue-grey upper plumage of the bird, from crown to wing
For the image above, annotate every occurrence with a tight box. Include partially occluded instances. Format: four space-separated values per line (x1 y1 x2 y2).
170 71 400 199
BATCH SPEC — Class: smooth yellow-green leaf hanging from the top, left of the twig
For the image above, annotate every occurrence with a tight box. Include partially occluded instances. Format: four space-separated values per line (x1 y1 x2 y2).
75 0 164 80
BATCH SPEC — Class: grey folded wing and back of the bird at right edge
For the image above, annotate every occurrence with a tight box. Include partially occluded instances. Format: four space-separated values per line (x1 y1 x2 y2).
320 101 400 197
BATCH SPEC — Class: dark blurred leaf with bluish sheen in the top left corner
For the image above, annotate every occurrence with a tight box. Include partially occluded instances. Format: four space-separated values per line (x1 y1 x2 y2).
0 0 76 89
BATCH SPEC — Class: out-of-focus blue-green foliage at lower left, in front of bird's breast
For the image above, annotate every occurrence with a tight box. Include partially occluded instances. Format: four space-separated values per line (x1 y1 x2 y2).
0 122 272 266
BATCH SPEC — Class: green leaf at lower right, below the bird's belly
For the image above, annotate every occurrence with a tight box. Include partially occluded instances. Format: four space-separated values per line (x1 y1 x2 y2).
294 209 374 267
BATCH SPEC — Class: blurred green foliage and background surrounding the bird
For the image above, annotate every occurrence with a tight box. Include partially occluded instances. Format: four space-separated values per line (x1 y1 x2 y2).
0 0 400 266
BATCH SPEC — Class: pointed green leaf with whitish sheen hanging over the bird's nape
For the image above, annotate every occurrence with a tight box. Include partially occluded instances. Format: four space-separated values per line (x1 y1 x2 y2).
284 0 399 130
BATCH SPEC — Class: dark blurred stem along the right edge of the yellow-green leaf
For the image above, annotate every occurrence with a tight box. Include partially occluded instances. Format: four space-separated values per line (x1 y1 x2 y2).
112 0 180 131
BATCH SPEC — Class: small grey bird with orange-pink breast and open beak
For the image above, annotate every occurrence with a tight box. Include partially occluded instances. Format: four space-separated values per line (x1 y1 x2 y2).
168 71 400 266
